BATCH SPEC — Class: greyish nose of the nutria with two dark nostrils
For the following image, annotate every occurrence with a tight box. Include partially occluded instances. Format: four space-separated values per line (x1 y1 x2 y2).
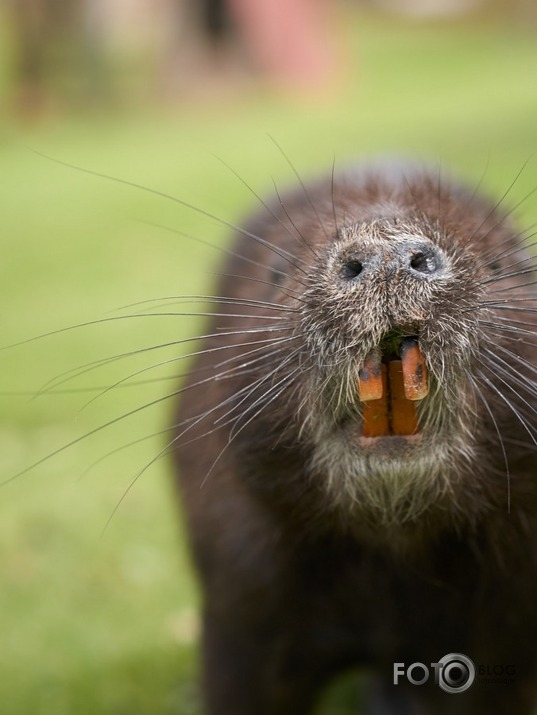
339 240 445 282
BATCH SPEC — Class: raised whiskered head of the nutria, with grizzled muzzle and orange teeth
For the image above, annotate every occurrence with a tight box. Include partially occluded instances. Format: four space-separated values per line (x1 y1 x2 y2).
199 170 537 533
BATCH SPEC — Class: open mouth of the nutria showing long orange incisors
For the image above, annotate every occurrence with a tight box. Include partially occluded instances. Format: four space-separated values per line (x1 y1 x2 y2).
358 334 429 438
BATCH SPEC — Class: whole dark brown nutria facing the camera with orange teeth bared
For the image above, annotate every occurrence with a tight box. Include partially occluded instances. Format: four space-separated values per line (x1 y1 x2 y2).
174 163 537 715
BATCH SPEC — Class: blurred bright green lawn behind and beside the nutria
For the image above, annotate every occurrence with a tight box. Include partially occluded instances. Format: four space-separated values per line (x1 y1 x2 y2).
0 9 537 715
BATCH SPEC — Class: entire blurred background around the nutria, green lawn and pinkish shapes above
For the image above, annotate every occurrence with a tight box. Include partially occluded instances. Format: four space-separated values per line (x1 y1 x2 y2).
0 0 537 715
